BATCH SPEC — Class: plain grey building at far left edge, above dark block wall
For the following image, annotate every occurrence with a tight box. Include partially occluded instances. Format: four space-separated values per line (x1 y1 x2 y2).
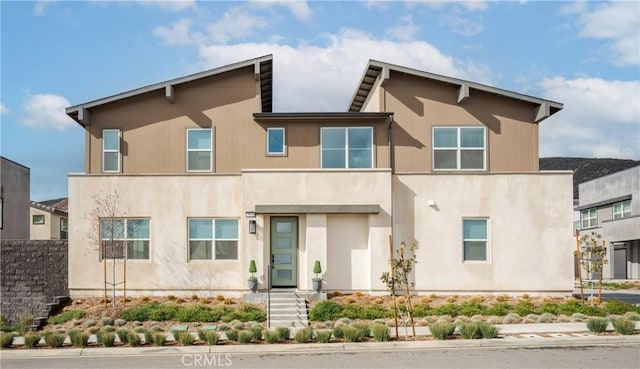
0 157 31 240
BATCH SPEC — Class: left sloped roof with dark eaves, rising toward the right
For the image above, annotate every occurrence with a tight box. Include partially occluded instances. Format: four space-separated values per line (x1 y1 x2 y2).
65 55 273 127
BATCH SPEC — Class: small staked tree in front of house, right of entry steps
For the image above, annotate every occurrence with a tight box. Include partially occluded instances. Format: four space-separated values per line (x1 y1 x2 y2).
380 242 418 337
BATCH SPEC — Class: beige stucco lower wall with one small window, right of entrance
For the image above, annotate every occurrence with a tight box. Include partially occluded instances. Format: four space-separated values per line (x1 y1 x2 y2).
393 172 575 294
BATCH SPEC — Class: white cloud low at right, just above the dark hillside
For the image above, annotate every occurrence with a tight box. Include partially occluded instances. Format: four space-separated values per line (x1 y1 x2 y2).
540 77 640 159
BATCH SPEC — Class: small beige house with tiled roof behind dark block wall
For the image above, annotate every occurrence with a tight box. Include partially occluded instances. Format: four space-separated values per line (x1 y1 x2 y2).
31 197 69 240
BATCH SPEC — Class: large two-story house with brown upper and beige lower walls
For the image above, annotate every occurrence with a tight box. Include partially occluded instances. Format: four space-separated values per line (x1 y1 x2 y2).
66 56 574 296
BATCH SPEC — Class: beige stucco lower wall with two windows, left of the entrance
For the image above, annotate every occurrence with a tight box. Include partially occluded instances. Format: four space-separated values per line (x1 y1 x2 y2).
69 175 242 296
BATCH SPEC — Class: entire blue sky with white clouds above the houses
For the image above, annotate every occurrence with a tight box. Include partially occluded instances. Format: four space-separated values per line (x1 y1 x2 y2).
0 0 640 201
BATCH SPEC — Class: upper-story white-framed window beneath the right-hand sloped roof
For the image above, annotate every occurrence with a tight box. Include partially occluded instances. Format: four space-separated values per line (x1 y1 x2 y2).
433 127 487 170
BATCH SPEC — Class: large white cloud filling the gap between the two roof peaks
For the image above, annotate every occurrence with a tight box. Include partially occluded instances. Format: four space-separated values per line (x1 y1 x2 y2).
199 29 488 111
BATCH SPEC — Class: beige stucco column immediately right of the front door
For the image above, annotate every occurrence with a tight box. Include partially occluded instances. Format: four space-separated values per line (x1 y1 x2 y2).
299 214 331 289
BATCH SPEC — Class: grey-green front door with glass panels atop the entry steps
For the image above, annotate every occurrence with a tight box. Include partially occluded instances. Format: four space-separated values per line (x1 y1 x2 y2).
271 217 298 287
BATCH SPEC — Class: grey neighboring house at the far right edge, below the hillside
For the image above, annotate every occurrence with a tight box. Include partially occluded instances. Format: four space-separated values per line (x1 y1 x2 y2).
576 165 640 280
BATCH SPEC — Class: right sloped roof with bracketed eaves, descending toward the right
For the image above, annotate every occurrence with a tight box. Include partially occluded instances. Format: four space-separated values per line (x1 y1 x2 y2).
348 60 563 123
